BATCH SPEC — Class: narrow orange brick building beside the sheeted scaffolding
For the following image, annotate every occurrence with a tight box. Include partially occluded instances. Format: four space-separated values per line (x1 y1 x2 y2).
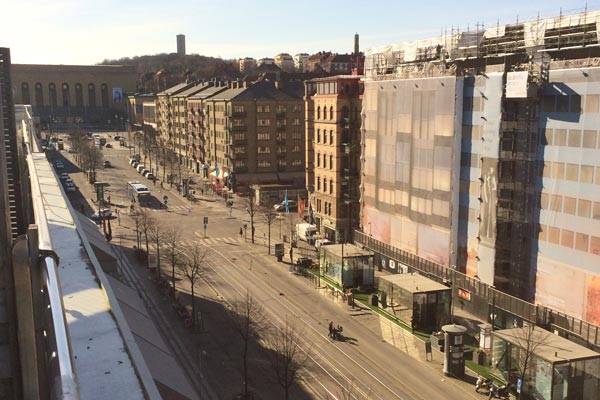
305 75 363 243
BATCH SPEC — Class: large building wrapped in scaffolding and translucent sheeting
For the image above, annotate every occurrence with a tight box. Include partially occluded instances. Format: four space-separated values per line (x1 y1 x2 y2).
361 11 600 324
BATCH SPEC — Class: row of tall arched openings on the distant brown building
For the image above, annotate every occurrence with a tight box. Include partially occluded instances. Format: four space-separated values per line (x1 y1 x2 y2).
21 82 110 108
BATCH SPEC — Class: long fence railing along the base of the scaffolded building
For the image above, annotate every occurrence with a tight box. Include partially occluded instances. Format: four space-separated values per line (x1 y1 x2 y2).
353 231 600 348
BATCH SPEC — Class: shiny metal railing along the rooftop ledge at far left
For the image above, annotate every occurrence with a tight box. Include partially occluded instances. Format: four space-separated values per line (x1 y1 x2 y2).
25 126 79 399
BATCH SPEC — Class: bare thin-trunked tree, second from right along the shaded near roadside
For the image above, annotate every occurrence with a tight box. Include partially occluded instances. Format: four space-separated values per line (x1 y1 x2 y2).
231 291 267 399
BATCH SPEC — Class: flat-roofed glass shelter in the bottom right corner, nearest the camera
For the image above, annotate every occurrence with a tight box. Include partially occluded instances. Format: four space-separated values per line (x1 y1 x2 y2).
492 326 600 400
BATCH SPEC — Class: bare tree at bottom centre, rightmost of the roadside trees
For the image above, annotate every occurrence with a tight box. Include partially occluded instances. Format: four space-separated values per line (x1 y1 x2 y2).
266 318 309 400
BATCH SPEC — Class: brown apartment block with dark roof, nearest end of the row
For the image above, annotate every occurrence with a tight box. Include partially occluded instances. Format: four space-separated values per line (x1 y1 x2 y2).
204 80 305 190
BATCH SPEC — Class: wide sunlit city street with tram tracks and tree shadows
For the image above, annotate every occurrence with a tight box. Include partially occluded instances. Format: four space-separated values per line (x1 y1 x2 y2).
61 136 484 400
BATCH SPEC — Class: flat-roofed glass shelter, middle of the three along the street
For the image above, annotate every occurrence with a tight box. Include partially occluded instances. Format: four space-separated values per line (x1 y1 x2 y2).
377 272 452 332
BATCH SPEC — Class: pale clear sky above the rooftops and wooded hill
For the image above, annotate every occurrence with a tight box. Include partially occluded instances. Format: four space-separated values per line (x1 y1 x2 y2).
0 0 600 65
